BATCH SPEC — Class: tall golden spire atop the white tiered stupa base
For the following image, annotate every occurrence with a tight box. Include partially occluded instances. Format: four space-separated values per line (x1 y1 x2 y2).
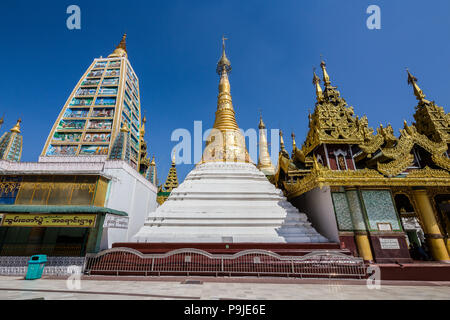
202 37 251 162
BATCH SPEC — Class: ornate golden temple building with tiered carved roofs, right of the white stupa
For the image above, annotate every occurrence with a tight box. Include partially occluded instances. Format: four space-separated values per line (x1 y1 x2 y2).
274 61 450 262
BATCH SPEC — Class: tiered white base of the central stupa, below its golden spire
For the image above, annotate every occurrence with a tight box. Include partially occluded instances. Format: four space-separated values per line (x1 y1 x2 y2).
133 162 328 243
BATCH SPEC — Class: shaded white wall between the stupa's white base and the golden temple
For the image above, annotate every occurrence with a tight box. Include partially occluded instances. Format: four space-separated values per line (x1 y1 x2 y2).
292 187 339 243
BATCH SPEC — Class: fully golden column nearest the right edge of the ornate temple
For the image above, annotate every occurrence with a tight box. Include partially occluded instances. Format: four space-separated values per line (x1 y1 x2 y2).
413 189 450 262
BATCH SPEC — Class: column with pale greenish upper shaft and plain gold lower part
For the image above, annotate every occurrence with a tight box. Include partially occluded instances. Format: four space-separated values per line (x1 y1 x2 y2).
345 189 373 261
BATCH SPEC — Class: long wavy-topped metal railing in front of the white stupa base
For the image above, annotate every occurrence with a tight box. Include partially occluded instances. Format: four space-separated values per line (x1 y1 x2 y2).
83 248 366 279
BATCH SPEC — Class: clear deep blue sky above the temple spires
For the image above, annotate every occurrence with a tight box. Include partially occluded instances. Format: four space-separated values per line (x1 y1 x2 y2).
0 0 450 182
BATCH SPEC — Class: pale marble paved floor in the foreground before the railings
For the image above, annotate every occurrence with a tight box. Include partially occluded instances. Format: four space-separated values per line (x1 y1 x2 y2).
0 276 450 300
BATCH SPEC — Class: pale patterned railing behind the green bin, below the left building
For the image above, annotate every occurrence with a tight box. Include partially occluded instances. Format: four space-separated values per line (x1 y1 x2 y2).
0 256 85 276
